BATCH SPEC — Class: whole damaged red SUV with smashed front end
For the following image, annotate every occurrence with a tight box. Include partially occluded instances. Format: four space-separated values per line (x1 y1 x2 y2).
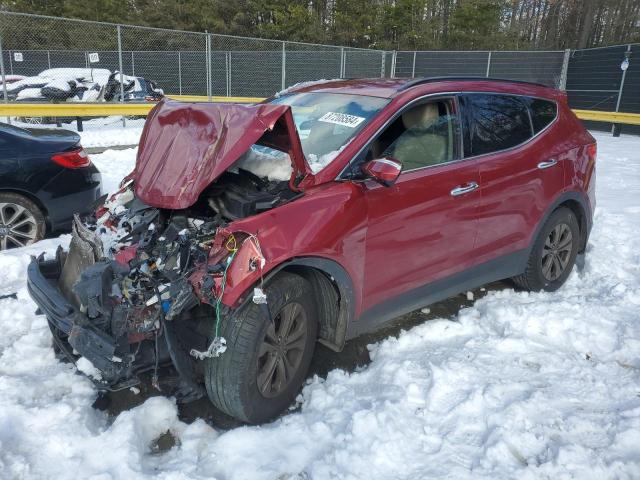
28 78 596 423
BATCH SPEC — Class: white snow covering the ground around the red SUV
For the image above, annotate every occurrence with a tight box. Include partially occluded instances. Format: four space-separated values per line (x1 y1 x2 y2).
0 133 640 480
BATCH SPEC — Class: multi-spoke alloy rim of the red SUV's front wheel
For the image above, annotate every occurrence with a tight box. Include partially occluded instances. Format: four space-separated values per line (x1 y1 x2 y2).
257 302 308 398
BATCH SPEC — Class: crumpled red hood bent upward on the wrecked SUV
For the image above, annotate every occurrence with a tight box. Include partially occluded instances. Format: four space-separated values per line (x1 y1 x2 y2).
129 99 311 209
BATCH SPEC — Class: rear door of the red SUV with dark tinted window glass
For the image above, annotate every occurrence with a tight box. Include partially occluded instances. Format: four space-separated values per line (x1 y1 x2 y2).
460 93 565 263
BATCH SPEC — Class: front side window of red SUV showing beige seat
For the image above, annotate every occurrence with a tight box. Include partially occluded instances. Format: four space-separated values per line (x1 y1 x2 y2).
362 100 460 171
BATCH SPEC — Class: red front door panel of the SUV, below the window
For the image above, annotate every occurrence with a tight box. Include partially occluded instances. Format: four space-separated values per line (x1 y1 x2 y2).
363 162 479 310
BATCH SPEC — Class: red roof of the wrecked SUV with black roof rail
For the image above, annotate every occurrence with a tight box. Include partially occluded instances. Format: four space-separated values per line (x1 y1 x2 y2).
287 76 551 98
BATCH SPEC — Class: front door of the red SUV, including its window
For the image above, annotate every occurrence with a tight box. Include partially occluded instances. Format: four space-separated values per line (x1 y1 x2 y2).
364 99 480 310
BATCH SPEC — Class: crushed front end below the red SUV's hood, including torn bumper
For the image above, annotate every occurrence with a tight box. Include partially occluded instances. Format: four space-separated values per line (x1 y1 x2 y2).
28 178 275 398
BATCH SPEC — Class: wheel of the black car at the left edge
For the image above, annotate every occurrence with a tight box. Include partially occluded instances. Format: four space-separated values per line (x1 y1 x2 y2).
0 192 46 250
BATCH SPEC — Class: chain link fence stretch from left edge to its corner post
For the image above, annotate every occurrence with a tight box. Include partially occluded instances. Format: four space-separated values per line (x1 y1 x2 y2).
0 12 386 100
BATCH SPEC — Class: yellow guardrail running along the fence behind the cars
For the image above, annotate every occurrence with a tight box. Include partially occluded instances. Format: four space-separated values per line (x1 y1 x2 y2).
0 99 640 125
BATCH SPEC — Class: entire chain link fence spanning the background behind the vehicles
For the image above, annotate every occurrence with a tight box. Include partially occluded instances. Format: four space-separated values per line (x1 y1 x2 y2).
0 12 640 131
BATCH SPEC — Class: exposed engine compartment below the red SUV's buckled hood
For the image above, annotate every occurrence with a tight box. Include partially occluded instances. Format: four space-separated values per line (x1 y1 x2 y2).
73 169 299 326
